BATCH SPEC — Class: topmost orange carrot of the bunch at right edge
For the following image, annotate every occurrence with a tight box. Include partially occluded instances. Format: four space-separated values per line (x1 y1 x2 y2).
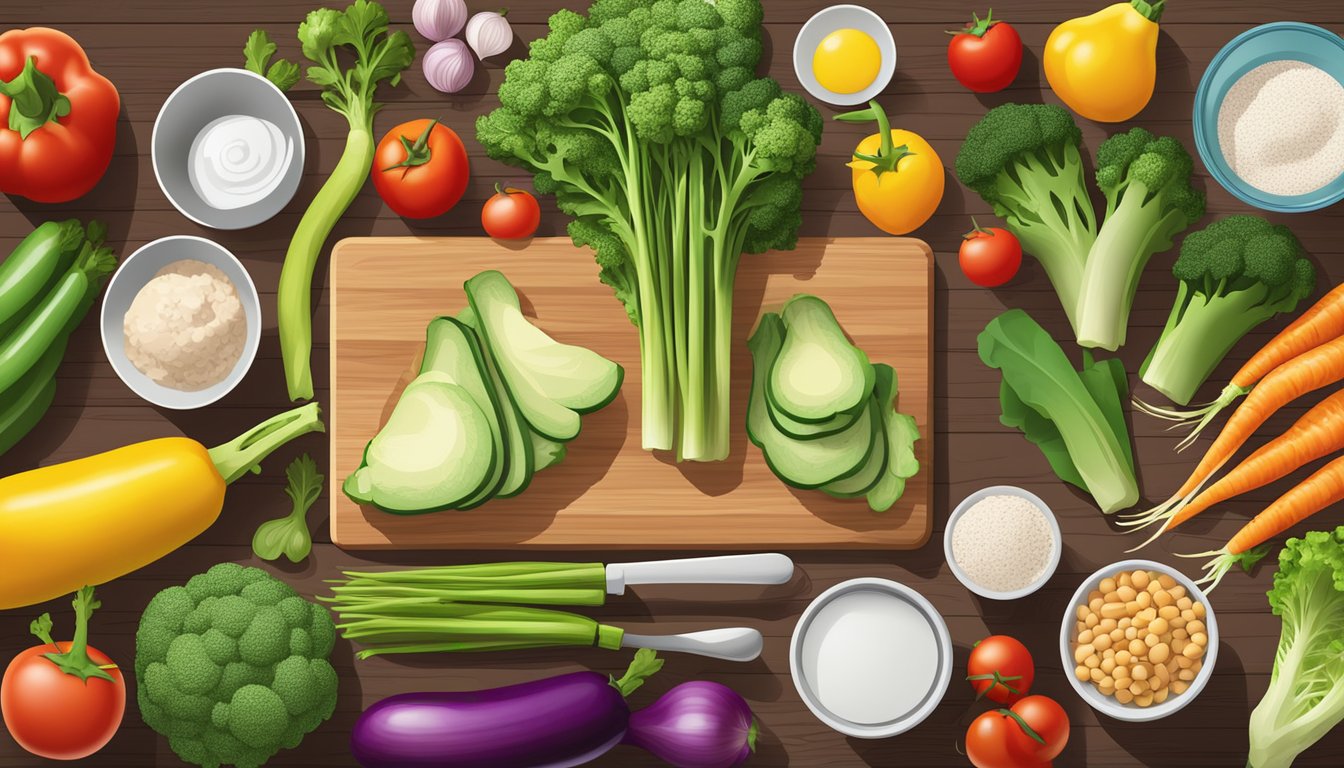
1134 284 1344 451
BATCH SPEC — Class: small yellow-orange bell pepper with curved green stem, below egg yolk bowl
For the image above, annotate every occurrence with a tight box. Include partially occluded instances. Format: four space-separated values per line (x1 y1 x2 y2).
836 101 943 234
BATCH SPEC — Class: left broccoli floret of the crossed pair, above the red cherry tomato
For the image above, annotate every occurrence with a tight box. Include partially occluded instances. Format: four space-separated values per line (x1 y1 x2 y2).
956 104 1097 328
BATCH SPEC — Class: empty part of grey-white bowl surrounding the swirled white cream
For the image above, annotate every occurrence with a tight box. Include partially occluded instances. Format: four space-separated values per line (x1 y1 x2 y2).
149 69 304 230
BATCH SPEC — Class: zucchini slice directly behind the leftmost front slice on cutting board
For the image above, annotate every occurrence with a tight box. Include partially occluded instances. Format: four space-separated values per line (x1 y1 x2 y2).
421 317 512 510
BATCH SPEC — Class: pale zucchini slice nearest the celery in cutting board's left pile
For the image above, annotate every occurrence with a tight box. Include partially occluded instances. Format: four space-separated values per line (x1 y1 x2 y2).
466 270 625 419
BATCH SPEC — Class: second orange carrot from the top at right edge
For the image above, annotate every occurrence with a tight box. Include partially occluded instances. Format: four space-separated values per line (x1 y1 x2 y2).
1126 336 1344 526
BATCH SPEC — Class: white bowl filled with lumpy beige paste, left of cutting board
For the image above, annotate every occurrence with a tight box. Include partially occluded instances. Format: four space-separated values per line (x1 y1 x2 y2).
101 235 261 410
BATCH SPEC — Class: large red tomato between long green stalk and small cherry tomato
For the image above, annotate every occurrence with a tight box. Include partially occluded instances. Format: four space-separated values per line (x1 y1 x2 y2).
372 120 470 219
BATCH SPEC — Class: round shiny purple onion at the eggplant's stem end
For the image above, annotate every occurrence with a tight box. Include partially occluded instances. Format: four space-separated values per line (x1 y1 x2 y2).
625 681 757 768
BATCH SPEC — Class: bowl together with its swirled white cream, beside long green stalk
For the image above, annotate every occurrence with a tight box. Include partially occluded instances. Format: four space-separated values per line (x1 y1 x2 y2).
151 69 304 230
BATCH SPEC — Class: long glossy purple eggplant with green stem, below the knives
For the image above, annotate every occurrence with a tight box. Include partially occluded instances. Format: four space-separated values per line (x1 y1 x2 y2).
351 651 663 768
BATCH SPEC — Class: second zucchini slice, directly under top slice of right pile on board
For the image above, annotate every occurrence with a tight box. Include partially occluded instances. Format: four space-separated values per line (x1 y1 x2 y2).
747 313 880 488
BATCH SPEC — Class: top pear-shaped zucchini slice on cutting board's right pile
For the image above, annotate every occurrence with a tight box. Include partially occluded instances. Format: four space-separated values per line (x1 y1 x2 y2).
766 295 874 424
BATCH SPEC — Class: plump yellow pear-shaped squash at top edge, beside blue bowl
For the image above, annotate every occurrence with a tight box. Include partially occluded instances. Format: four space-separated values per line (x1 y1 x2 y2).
1044 0 1165 122
